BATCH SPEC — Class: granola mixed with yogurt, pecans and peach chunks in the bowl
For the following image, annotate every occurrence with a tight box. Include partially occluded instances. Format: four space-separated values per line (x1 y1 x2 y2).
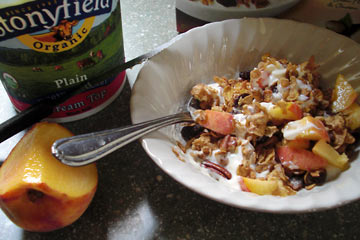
173 54 360 196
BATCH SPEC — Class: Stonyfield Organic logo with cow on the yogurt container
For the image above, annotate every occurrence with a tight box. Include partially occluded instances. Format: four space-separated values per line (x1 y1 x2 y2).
0 0 112 53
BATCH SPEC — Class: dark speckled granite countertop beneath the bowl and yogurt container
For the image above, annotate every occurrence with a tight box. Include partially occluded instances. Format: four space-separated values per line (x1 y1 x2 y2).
0 0 360 240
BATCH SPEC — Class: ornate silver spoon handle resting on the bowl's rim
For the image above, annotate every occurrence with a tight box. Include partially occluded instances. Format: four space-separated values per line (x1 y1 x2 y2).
51 112 193 166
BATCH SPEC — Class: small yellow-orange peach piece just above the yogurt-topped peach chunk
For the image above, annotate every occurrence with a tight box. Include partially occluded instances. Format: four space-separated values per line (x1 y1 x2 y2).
268 102 303 120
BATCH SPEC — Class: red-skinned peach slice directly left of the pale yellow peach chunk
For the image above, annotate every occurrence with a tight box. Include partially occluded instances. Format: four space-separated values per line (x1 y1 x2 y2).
276 146 328 171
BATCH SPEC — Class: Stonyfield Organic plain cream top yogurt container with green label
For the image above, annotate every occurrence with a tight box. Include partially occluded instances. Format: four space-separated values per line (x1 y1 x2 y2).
0 0 125 122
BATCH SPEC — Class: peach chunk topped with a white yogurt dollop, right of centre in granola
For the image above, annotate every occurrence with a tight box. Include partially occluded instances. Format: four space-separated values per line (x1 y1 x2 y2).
282 116 330 142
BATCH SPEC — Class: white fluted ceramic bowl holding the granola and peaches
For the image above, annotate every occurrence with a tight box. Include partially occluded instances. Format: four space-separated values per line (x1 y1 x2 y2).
131 18 360 212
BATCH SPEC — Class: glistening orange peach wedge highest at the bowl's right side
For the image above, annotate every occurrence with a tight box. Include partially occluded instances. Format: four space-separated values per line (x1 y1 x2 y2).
331 74 358 113
